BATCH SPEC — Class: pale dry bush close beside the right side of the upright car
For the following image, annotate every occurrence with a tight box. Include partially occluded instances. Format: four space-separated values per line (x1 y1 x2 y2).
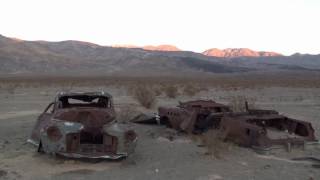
117 105 138 123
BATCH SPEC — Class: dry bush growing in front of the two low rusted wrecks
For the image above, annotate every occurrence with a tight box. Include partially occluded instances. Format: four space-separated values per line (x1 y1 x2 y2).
200 129 232 159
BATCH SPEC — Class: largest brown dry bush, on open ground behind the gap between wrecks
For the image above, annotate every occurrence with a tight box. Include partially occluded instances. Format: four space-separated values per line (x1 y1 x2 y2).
132 86 156 109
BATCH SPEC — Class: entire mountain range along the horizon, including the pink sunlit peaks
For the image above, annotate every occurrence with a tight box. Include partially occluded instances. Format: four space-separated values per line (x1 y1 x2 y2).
0 35 320 74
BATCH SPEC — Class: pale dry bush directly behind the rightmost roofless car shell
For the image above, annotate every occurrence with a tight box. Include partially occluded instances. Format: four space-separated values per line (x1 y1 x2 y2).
229 96 256 112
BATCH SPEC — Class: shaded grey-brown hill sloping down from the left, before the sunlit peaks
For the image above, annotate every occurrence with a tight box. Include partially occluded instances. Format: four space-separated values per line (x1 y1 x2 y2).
0 36 248 74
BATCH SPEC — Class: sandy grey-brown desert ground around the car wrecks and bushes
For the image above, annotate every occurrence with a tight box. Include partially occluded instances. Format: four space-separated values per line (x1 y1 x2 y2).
0 75 320 180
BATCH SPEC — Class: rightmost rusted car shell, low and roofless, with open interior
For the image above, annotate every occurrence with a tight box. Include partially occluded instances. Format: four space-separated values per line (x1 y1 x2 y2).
219 110 316 151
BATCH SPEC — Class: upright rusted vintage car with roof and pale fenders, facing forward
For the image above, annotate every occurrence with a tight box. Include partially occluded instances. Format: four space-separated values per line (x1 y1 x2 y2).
28 92 137 159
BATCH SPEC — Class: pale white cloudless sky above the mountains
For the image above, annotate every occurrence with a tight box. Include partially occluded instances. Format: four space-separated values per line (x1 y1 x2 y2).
0 0 320 55
